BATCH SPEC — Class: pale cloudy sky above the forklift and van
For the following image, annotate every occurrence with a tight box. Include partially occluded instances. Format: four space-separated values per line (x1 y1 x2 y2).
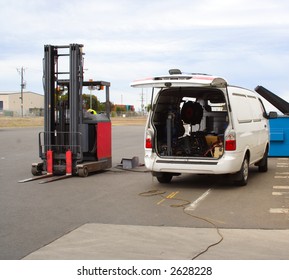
0 0 289 110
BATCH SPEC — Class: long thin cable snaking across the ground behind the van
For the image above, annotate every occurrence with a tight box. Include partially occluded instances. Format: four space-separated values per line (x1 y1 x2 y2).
139 189 224 260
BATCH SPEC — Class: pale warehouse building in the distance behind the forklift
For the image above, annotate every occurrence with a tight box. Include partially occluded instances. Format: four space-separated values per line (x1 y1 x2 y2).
0 91 44 117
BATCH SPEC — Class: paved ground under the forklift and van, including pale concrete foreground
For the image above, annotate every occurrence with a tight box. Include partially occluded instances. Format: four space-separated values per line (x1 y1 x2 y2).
0 126 289 260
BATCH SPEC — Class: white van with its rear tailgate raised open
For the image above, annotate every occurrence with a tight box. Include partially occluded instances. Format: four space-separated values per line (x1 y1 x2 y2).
131 69 269 185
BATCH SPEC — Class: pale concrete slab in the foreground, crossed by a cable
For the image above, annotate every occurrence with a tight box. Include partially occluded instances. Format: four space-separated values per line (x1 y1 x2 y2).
24 224 289 260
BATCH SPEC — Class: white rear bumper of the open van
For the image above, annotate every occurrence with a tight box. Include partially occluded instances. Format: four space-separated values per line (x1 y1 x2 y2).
145 153 243 174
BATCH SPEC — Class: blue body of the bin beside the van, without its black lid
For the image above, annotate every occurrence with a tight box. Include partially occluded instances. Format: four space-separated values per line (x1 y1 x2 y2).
269 116 289 157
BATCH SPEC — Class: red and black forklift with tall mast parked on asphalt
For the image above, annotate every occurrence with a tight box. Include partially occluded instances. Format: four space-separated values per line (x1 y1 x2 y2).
19 44 112 183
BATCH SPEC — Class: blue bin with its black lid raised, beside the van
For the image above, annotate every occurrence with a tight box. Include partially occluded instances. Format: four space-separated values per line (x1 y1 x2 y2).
255 86 289 157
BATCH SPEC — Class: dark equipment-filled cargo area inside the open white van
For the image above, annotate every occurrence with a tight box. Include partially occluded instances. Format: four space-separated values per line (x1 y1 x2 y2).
152 88 228 157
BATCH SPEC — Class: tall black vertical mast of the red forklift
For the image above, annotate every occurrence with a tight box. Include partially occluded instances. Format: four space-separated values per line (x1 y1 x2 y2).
43 44 83 154
